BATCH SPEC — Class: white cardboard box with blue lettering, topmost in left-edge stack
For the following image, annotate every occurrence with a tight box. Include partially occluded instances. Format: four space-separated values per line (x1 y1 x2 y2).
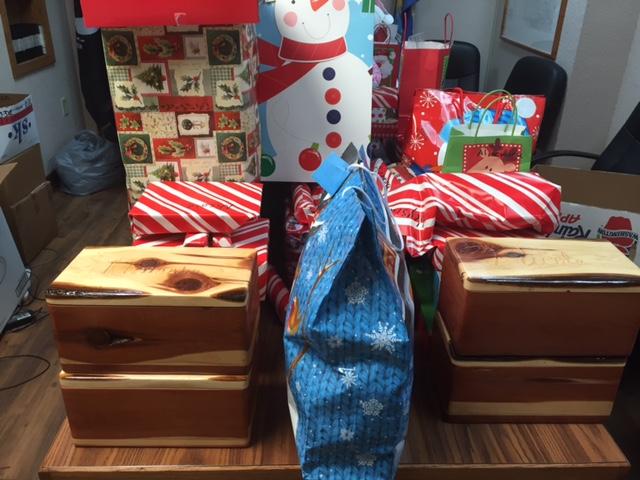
0 93 40 163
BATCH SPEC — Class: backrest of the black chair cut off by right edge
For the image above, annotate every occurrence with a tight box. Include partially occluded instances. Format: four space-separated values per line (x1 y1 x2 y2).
593 103 640 175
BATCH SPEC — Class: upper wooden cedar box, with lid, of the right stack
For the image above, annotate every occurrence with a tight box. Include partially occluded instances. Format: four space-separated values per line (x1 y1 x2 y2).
439 238 640 357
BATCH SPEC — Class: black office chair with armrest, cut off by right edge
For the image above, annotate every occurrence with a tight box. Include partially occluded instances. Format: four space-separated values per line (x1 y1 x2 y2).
533 103 640 175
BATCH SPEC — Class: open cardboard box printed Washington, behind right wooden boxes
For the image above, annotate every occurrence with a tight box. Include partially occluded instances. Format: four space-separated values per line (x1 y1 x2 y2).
534 165 640 265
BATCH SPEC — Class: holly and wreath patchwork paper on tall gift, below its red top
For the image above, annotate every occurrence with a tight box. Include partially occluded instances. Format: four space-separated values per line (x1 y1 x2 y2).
103 25 261 204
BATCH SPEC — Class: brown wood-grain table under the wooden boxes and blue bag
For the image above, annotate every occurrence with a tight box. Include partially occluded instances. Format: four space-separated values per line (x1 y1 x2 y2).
40 314 629 480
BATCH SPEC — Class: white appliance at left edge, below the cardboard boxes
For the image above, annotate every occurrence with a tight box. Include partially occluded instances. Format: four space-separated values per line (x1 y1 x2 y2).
0 210 30 333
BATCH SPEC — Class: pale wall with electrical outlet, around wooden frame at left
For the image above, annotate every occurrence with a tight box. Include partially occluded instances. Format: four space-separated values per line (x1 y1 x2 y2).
0 0 84 173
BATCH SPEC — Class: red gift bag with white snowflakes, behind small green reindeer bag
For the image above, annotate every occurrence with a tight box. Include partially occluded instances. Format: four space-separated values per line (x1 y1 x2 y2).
403 89 546 172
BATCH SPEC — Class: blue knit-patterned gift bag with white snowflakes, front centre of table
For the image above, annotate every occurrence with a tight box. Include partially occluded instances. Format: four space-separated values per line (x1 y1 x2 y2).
285 155 413 480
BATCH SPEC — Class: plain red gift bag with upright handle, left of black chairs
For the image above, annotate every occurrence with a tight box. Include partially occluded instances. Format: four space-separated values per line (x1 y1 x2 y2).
398 14 453 132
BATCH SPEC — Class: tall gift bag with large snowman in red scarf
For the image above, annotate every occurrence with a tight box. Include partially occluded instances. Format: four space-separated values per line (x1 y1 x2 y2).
258 0 375 182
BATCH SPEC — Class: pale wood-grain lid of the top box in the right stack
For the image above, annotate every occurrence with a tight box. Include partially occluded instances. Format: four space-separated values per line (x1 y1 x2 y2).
447 238 640 293
